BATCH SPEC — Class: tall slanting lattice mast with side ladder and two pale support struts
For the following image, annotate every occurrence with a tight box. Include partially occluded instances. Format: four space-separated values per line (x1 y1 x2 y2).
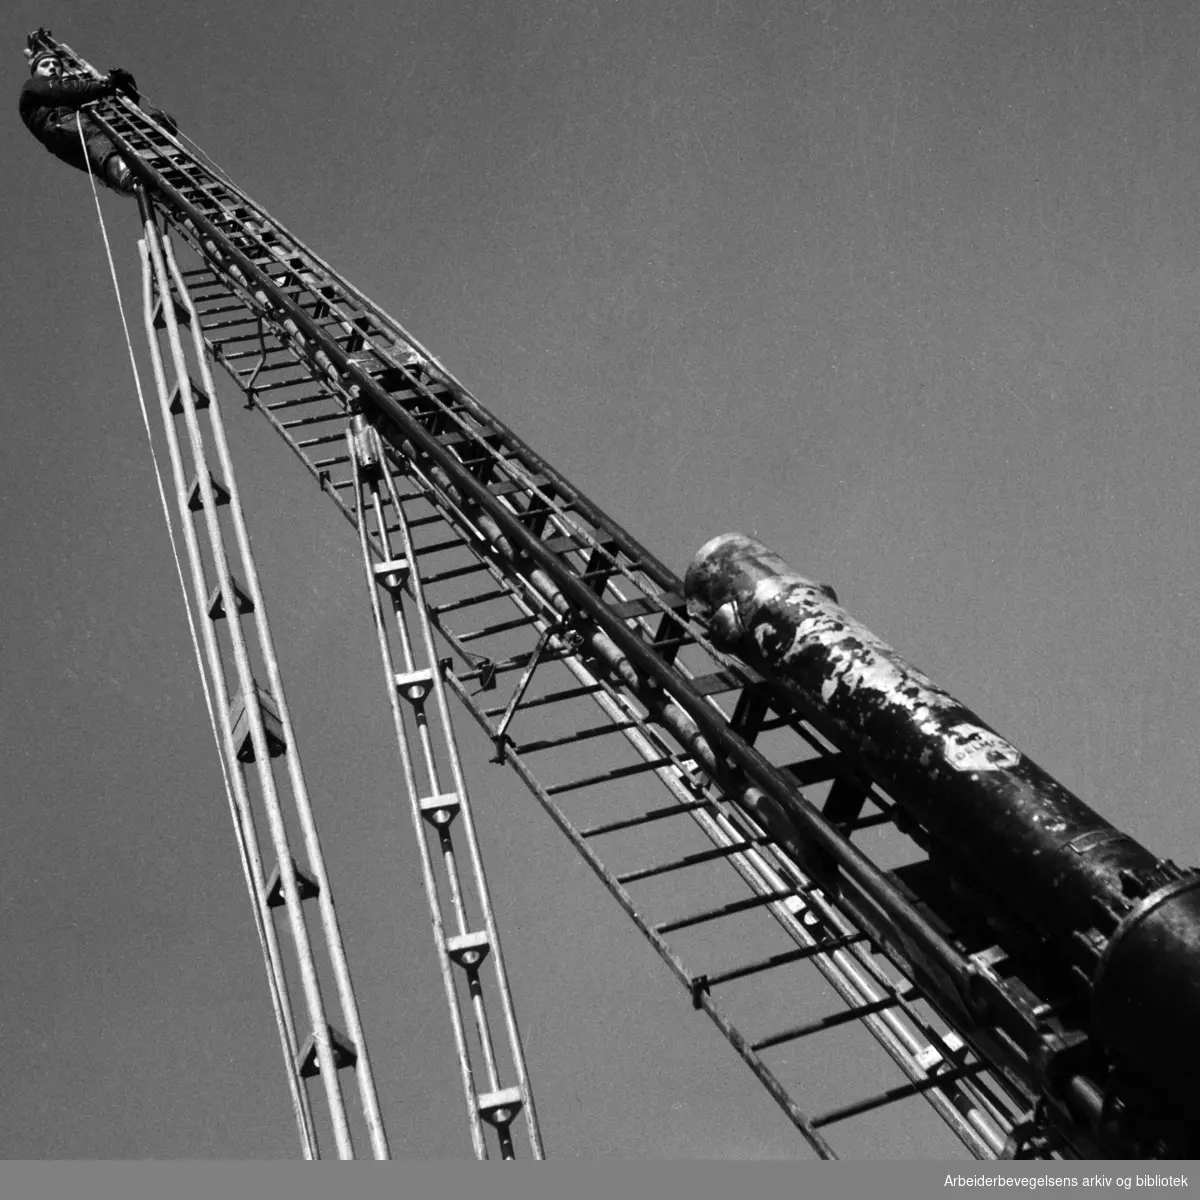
34 31 1196 1158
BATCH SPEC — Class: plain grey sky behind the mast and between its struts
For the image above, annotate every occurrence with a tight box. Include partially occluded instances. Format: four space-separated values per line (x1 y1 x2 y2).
7 0 1200 1158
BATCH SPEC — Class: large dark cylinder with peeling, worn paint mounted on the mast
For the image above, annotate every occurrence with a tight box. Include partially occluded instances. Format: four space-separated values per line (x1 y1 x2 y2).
685 534 1200 1113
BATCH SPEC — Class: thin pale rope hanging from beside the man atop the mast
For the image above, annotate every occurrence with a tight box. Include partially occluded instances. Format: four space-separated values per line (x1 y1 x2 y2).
77 120 318 1159
